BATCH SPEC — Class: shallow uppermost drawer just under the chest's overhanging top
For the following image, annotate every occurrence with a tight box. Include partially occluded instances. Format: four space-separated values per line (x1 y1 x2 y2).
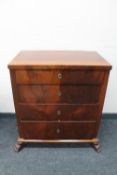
15 70 104 85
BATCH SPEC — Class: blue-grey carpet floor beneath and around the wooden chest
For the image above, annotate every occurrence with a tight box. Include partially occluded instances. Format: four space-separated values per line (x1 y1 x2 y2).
0 115 117 175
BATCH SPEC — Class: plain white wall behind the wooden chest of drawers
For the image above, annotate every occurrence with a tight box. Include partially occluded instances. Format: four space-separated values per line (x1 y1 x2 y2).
0 0 117 113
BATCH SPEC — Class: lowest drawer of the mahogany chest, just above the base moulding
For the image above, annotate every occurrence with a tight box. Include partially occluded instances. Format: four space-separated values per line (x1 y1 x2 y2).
20 122 96 139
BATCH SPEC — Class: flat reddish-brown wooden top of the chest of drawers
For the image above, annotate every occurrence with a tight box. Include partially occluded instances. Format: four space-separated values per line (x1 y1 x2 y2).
9 51 111 69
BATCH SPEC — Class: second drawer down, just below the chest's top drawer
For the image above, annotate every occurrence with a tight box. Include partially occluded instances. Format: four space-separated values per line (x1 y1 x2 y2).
18 85 101 104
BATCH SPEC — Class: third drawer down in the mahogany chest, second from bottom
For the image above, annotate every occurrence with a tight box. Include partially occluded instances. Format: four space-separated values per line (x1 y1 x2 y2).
19 105 100 122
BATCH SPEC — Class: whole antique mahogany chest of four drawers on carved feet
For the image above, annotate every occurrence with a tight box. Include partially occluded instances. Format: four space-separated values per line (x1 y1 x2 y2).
8 51 111 151
